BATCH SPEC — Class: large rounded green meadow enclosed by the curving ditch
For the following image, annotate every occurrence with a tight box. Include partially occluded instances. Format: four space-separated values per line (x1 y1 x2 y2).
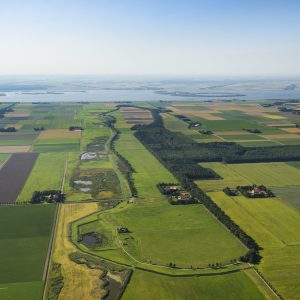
101 202 246 268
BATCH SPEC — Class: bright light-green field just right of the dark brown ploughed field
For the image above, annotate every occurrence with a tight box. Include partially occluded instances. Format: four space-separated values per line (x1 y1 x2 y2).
17 153 67 202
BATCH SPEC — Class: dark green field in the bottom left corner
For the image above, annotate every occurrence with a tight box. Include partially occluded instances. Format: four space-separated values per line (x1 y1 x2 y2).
0 205 55 300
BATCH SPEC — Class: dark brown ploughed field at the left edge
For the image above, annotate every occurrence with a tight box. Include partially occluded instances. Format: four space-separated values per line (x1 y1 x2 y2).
0 153 38 204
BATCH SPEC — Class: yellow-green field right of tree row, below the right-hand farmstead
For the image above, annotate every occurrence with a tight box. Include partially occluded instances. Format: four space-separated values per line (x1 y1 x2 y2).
209 192 300 299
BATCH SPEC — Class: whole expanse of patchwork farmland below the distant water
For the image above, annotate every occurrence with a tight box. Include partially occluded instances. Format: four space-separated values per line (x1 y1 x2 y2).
0 101 300 300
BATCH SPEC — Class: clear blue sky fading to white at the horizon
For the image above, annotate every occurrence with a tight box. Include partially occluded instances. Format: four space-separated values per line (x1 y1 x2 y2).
0 0 300 76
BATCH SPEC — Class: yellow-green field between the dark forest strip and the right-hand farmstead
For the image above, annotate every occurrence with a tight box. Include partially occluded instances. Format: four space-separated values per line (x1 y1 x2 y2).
197 162 300 191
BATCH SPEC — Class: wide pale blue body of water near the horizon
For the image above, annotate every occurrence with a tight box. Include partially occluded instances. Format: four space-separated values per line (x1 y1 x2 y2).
0 90 300 102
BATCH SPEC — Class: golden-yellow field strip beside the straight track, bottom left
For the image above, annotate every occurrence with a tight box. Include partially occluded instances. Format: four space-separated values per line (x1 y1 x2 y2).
52 203 104 300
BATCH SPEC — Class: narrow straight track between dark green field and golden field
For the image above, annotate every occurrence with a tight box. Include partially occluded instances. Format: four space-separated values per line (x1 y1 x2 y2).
42 204 60 299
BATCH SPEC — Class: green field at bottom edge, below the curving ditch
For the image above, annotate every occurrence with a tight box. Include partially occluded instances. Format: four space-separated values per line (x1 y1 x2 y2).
123 271 265 300
